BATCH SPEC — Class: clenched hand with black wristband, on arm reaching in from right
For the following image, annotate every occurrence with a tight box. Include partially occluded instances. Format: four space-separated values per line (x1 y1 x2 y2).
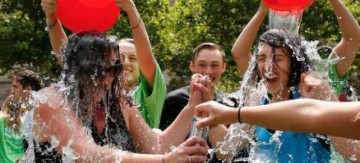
195 101 237 128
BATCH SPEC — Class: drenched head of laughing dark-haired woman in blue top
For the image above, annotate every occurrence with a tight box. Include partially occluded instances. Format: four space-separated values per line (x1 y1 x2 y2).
256 29 310 98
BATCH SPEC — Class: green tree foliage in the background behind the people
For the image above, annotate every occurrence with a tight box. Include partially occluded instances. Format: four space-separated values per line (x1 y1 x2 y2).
0 0 360 92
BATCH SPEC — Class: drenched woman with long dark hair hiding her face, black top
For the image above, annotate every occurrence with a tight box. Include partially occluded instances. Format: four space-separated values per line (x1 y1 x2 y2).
24 31 207 162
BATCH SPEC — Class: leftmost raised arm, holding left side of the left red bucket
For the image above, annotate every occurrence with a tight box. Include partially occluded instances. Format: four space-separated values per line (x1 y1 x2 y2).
41 0 68 65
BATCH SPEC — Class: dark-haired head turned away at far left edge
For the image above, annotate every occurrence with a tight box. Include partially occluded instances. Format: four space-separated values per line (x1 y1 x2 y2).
11 69 44 99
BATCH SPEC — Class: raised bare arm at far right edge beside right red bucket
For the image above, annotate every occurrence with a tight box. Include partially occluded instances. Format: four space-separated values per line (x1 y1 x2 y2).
329 0 360 77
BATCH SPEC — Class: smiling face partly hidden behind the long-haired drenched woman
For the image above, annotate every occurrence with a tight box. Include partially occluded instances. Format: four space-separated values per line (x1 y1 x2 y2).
119 38 140 88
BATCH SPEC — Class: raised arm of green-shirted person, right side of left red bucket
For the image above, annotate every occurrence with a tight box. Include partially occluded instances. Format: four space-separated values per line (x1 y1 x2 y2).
116 0 156 88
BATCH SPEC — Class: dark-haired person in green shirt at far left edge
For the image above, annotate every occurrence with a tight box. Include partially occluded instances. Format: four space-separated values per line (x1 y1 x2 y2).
0 70 43 163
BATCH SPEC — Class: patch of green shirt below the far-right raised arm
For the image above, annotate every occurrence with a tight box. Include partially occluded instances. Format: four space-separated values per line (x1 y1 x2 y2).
329 64 349 96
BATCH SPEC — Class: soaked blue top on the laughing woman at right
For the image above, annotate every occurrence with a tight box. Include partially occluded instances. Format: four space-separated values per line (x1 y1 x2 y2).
255 89 331 163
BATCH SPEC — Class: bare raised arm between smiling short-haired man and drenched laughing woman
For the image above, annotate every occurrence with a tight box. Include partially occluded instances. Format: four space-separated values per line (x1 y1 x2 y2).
231 3 268 76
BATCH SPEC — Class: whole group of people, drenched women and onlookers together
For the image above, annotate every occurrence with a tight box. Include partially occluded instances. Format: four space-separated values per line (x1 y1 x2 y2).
0 0 360 163
